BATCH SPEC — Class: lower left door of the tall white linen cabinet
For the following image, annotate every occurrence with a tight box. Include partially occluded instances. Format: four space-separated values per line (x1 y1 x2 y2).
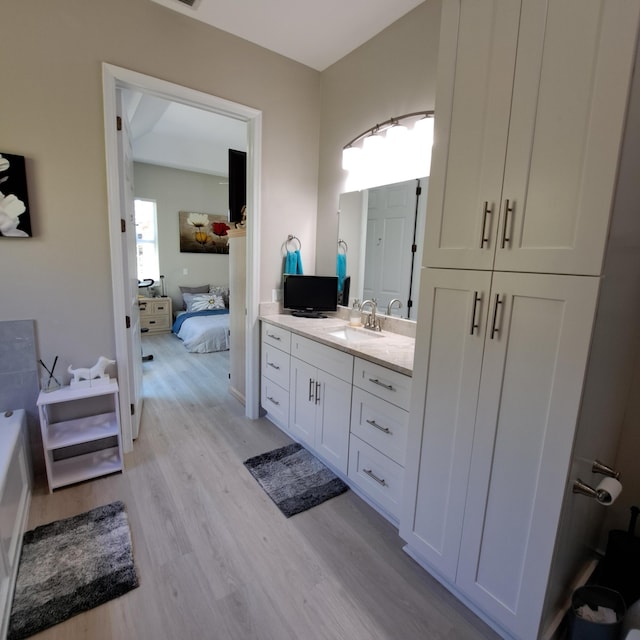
400 269 491 582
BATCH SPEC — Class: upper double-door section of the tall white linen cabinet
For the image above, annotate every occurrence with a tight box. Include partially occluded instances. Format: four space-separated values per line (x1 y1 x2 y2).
423 0 640 275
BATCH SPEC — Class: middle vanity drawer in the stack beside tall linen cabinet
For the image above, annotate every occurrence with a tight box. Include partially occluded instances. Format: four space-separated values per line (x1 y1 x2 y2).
351 387 409 466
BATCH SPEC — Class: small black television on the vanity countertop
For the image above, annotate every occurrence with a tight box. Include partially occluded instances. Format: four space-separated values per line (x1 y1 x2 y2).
283 275 338 318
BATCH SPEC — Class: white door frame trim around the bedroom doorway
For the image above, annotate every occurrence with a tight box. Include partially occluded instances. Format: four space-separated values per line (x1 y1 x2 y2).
102 62 262 452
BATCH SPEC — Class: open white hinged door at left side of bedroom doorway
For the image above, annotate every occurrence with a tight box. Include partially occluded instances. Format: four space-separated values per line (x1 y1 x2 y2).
116 89 142 439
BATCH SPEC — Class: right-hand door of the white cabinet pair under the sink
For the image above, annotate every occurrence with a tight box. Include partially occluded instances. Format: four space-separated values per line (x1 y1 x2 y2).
315 370 351 475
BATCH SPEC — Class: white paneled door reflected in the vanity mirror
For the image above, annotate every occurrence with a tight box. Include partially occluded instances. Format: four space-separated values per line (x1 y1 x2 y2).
362 180 419 317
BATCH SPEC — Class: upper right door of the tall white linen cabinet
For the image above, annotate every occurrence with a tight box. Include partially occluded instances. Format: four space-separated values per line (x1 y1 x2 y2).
496 0 640 275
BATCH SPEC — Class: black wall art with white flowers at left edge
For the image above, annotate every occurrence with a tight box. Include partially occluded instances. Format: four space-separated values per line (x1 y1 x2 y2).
0 153 31 238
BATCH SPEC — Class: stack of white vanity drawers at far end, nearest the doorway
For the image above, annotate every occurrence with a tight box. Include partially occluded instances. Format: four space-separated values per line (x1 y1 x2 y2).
260 322 291 430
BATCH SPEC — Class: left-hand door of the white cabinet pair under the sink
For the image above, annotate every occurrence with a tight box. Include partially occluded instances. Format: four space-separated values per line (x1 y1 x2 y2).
289 358 319 448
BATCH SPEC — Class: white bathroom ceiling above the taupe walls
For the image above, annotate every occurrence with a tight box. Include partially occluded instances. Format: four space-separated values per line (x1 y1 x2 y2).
152 0 424 71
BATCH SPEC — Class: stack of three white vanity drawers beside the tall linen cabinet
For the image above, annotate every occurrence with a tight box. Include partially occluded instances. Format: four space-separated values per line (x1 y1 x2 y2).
348 358 411 522
